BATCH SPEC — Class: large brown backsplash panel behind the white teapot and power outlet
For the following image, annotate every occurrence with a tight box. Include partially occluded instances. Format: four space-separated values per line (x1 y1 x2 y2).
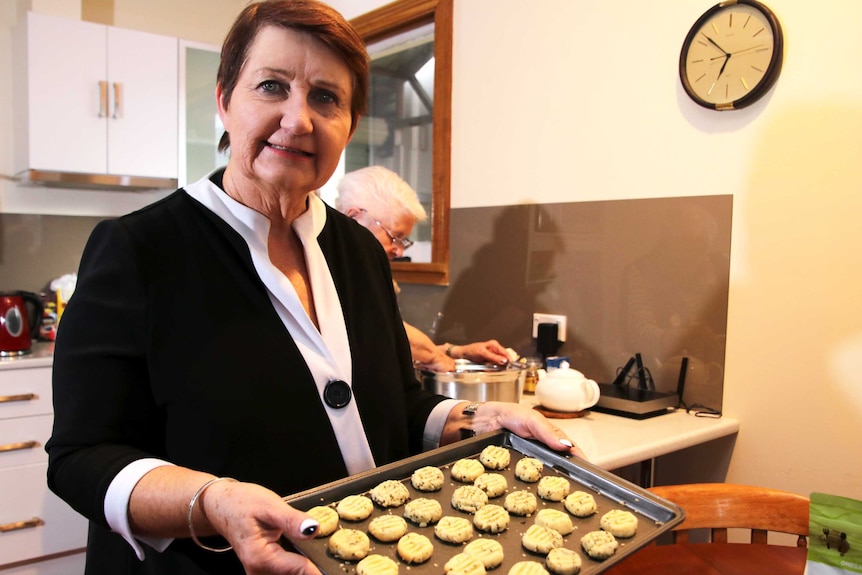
400 195 733 409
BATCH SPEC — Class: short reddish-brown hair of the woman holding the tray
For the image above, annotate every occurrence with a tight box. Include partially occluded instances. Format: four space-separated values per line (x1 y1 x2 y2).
216 0 369 152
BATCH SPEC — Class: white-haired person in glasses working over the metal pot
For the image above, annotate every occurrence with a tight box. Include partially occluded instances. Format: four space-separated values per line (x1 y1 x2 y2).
335 166 510 372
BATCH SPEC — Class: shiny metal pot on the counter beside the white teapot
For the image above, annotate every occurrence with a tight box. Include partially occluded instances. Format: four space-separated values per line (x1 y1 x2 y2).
416 360 526 403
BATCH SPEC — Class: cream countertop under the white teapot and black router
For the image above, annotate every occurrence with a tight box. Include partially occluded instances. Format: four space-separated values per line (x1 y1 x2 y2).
521 395 739 469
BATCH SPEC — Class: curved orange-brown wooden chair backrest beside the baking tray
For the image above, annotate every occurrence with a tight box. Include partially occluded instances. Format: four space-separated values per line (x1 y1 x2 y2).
649 483 810 547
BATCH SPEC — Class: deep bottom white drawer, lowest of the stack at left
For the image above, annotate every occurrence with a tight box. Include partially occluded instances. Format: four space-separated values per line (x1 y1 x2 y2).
0 463 87 567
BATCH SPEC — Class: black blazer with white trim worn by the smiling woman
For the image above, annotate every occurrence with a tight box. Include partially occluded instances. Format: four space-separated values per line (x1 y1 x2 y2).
46 182 443 575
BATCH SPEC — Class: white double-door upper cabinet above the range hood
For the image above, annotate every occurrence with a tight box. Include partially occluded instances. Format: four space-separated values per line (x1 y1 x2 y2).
15 12 178 179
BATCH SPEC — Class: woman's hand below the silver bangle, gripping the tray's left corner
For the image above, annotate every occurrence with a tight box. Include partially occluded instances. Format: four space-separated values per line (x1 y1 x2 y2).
198 481 320 575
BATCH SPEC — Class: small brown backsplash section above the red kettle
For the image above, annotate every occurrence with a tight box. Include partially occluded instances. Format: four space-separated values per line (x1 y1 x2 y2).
0 214 103 293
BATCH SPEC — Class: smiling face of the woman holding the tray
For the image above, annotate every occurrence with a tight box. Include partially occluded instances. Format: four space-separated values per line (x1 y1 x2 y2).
216 26 353 196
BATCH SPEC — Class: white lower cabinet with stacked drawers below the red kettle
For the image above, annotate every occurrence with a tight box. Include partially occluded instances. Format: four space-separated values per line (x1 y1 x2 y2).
0 359 87 575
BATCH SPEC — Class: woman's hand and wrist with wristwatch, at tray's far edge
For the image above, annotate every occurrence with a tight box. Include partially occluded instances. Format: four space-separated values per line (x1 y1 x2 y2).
440 401 586 459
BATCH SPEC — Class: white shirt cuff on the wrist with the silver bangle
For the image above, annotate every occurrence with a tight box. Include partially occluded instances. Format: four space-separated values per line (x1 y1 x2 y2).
105 458 173 561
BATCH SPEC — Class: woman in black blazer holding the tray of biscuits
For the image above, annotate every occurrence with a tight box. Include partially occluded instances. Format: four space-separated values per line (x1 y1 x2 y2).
46 0 579 575
